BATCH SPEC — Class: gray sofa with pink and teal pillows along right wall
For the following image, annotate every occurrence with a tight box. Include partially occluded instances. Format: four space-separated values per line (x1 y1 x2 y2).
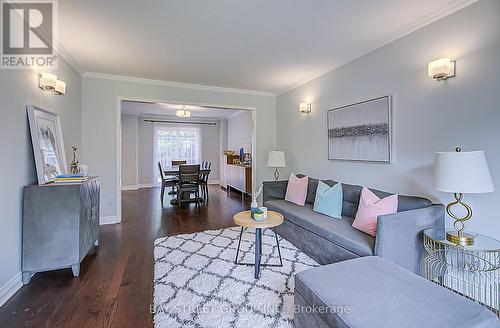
263 175 444 274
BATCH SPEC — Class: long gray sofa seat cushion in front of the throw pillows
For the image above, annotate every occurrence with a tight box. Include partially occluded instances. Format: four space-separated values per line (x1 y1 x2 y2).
264 200 375 256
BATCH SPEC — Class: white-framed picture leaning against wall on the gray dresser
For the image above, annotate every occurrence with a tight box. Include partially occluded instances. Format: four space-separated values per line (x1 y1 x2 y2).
26 105 68 185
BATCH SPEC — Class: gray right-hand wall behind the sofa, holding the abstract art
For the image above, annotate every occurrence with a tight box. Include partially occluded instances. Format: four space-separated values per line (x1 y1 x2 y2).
276 0 500 239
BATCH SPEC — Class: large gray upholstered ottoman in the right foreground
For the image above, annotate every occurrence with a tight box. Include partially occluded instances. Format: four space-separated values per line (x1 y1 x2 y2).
295 256 500 328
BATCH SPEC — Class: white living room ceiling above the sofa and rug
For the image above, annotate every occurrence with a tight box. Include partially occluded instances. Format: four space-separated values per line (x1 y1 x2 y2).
59 0 475 94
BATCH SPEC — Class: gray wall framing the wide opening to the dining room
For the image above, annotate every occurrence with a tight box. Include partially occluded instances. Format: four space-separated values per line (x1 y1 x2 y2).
82 74 276 222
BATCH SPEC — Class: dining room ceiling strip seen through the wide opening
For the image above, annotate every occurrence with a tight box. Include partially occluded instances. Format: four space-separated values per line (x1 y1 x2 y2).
122 101 241 119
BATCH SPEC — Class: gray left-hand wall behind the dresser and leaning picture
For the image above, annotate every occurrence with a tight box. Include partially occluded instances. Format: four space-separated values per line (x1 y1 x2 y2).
0 57 81 304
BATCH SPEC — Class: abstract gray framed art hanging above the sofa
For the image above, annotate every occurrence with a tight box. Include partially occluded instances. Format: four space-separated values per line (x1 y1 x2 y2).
327 96 392 163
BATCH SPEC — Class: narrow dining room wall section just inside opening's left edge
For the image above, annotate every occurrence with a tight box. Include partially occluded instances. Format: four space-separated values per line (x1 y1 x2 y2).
122 115 138 187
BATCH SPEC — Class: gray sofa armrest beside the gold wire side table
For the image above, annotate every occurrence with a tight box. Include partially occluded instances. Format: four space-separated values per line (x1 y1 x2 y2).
375 204 444 275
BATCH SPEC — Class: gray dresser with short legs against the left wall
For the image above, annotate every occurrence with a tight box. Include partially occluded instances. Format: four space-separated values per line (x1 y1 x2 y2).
22 177 100 285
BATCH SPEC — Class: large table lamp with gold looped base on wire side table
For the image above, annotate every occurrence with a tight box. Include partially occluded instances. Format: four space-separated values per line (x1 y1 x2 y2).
434 148 495 245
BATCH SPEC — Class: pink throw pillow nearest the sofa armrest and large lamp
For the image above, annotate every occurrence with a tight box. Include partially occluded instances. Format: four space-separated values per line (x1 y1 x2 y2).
352 187 398 237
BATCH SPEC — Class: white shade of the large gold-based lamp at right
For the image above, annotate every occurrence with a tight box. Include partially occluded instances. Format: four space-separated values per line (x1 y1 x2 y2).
434 151 495 194
